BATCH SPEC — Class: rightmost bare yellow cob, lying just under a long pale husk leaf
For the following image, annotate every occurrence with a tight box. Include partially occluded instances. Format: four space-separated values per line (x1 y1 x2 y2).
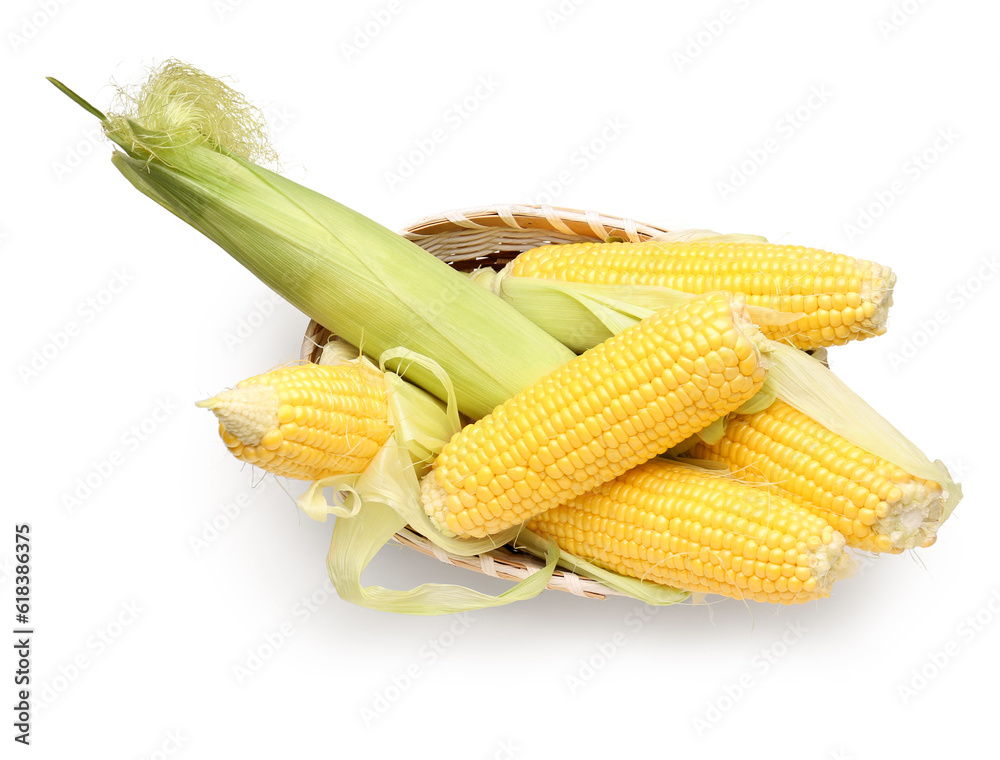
689 401 946 553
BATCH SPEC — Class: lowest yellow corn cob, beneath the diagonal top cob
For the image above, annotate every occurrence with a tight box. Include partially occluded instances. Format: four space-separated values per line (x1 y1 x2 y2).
527 459 850 604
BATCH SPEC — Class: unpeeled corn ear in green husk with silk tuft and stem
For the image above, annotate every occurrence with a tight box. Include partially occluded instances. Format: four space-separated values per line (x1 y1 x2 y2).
50 61 573 418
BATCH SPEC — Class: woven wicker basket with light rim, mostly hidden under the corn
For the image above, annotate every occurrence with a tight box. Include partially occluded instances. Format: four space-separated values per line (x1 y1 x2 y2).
301 205 702 599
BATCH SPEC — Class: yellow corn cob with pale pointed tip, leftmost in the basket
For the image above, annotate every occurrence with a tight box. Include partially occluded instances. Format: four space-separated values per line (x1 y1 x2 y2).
198 363 392 480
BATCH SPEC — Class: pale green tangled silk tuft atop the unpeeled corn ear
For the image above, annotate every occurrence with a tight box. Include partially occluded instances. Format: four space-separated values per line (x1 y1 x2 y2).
108 59 278 168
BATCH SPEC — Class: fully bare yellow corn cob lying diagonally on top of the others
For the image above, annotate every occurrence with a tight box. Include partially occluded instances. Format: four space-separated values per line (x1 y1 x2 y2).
422 293 765 538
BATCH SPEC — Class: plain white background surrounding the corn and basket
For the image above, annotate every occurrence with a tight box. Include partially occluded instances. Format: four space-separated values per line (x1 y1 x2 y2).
0 0 1000 760
